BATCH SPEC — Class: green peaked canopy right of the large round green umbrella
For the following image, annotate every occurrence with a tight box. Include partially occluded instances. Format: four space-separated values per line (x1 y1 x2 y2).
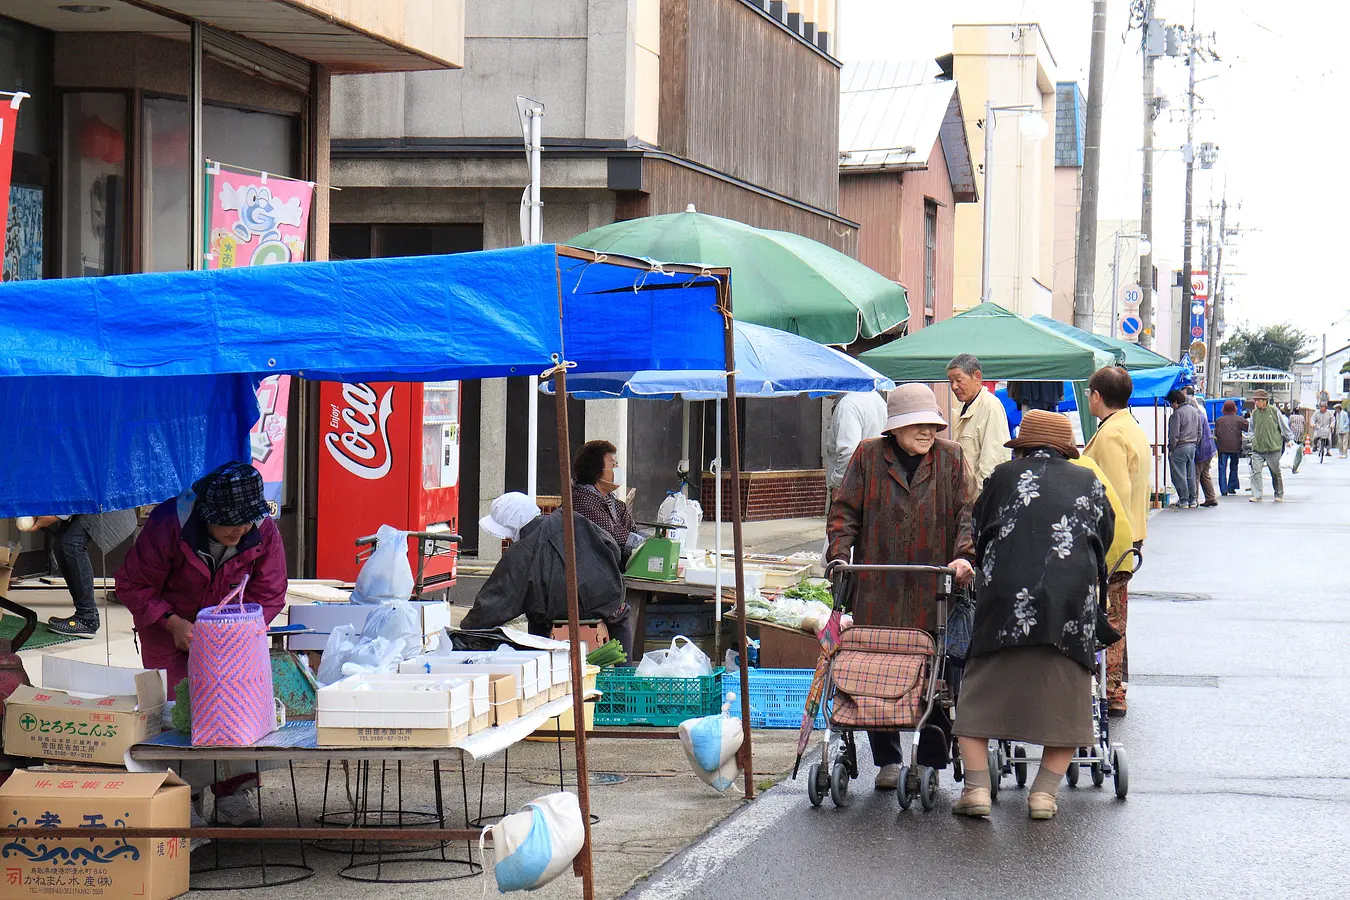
858 302 1125 383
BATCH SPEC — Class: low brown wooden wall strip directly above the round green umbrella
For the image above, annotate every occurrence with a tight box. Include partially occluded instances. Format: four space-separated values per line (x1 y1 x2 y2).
614 157 857 256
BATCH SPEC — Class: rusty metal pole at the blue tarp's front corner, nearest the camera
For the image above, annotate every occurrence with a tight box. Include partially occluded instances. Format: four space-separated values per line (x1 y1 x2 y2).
554 359 595 900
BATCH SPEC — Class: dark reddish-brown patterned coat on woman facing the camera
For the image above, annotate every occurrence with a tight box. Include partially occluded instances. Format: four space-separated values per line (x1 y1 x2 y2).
826 434 975 631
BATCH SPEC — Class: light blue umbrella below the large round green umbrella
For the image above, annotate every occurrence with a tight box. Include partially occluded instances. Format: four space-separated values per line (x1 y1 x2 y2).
544 321 895 399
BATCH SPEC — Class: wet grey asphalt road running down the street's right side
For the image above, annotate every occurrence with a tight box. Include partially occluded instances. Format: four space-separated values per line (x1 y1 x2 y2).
628 457 1350 900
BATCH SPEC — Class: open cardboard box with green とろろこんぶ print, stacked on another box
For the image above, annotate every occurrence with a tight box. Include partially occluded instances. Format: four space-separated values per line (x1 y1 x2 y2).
4 656 165 765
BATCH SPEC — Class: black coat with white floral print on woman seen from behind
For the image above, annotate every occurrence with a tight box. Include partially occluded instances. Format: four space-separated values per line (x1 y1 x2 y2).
969 451 1115 669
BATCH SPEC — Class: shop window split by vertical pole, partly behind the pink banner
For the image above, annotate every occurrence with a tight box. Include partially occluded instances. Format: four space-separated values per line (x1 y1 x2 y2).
143 97 300 271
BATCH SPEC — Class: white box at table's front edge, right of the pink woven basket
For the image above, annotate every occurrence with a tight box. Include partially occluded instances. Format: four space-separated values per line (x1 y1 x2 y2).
315 673 475 729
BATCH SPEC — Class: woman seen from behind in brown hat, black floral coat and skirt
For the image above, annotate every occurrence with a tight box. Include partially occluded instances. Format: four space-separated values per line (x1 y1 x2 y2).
952 410 1116 819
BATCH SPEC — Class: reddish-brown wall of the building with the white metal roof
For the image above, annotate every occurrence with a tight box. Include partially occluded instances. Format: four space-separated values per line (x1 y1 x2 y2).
840 142 956 332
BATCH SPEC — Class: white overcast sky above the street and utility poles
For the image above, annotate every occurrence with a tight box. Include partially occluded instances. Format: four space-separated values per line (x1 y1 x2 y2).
838 0 1350 349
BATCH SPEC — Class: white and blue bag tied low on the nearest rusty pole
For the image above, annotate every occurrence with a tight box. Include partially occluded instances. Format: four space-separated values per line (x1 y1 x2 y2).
478 792 586 893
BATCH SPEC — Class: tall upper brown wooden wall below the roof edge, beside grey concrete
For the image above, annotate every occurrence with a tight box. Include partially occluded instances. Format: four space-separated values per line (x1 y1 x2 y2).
660 0 840 214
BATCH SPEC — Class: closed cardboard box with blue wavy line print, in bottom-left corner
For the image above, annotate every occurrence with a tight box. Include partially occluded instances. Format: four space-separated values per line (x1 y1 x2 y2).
0 769 190 900
